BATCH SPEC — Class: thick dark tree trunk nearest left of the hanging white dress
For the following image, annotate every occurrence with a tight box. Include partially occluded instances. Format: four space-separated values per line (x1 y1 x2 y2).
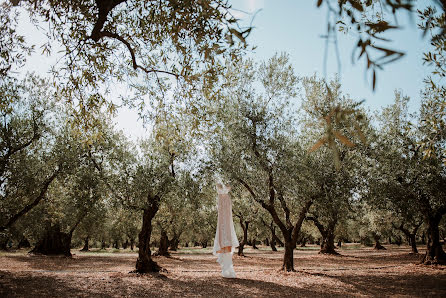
136 197 161 273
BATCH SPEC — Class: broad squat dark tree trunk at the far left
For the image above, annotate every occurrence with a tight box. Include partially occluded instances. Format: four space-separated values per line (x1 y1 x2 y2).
30 224 72 257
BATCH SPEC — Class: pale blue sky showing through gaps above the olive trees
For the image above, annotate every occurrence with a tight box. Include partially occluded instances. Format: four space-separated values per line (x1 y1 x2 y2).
9 0 431 138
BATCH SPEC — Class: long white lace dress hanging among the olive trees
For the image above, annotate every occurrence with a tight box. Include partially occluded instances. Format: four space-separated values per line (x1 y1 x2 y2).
213 183 239 278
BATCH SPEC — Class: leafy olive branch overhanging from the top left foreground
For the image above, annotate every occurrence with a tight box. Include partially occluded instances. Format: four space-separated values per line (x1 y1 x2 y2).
0 0 250 129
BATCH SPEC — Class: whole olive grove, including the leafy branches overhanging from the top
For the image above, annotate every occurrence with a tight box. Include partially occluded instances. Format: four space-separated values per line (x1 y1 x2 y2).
0 0 446 272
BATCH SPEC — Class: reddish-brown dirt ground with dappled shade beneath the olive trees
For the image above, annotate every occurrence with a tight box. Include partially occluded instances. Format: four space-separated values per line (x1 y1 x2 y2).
0 246 446 297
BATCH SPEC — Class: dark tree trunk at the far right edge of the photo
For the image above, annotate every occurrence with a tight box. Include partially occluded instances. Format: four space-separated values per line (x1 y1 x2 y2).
423 215 446 264
